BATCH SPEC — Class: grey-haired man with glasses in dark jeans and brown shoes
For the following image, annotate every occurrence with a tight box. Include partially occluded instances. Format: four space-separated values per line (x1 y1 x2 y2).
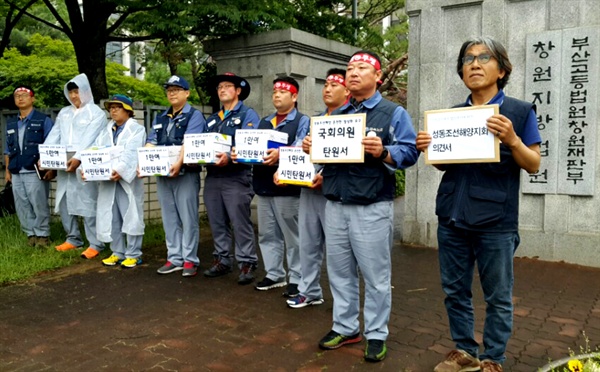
416 37 541 372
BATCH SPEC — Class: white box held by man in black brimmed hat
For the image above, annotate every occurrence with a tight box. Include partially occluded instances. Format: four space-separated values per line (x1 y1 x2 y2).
183 133 231 164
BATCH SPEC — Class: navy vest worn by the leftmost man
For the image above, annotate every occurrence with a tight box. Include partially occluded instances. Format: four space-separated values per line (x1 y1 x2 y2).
6 110 48 174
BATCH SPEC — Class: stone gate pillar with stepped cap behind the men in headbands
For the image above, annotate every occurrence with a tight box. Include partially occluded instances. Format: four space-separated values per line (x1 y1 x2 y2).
204 28 357 116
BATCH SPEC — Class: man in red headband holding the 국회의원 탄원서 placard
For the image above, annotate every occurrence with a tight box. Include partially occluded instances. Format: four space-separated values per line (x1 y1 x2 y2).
310 51 418 362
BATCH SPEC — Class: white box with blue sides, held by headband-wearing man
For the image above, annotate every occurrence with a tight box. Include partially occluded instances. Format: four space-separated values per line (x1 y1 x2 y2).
235 129 288 163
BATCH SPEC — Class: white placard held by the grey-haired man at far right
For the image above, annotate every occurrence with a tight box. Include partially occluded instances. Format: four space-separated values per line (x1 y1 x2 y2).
425 105 500 164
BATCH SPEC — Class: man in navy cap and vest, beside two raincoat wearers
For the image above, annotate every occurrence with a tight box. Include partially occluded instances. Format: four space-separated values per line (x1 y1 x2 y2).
146 75 206 277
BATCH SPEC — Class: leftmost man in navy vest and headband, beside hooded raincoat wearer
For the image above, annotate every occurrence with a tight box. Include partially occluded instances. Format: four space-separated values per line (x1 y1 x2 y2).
4 85 52 247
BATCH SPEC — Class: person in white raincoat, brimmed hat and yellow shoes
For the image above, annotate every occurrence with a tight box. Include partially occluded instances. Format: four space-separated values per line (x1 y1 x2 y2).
96 94 146 268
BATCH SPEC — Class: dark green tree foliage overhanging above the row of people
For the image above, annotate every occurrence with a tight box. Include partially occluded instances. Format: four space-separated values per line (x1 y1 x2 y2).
0 0 407 106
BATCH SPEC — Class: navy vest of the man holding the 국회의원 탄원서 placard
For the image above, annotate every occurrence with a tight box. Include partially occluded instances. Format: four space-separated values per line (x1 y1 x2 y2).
321 98 398 205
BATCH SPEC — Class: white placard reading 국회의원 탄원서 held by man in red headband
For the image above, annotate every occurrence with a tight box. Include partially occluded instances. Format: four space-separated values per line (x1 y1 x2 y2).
310 114 367 163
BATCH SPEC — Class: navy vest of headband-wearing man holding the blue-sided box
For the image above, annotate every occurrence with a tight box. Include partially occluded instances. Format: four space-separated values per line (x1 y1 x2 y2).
252 111 306 196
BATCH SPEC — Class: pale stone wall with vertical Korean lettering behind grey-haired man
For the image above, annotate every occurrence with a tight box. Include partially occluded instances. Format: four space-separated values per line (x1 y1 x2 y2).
404 0 600 267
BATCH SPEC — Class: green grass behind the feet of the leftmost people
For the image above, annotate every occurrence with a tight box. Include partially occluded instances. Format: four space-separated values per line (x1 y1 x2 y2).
0 215 165 285
